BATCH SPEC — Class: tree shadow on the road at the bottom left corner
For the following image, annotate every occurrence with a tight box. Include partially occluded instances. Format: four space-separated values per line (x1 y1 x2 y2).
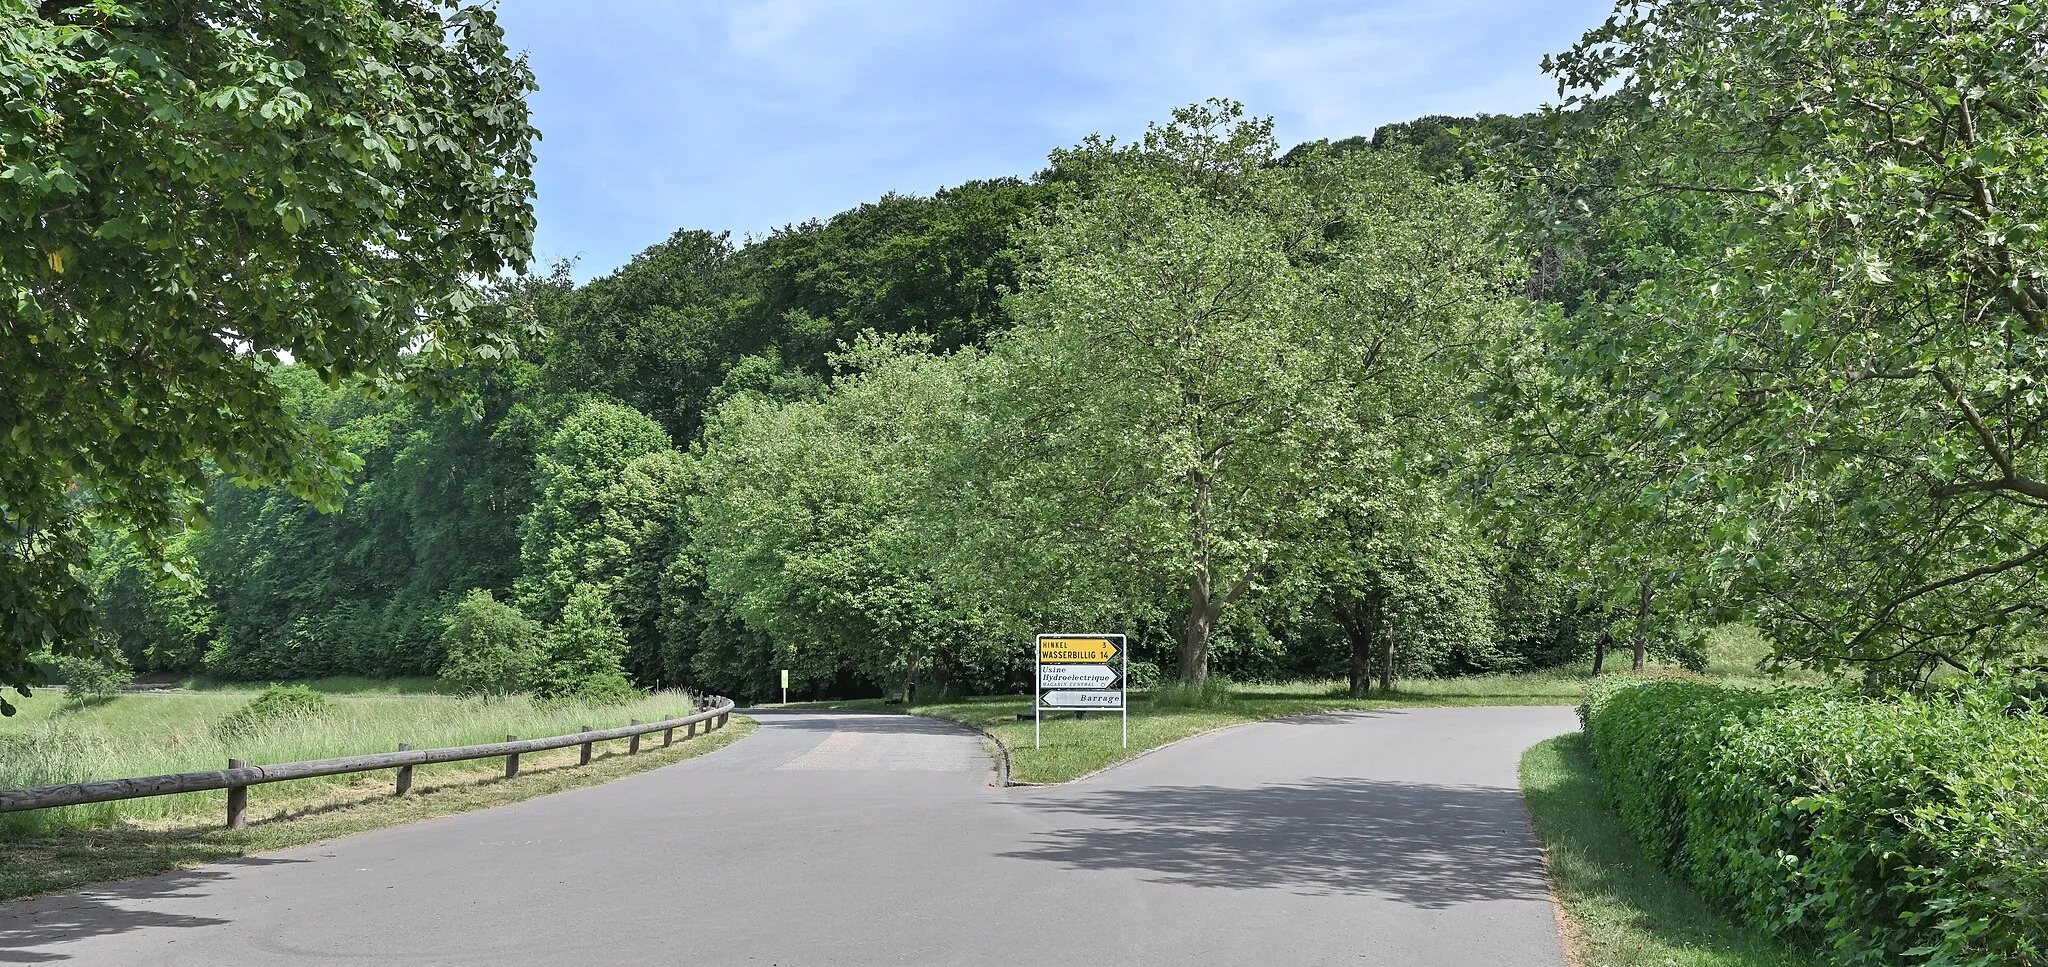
0 856 307 963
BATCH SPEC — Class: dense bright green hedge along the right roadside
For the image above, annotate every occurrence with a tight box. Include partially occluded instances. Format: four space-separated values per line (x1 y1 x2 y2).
1579 678 2048 967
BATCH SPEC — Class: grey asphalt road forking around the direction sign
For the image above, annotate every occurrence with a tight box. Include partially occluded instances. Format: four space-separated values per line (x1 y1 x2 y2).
0 709 1575 967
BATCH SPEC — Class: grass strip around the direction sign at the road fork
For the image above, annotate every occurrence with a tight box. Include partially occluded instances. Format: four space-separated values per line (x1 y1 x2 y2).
807 672 1585 783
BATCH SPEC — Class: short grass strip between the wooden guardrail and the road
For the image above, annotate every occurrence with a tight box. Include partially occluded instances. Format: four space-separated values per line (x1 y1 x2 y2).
0 715 754 899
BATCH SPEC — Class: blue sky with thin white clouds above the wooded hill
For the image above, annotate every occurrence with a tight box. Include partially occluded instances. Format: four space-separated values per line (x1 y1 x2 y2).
500 0 1612 279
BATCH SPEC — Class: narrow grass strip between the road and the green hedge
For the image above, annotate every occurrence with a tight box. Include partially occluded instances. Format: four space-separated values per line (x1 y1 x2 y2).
1522 733 1825 967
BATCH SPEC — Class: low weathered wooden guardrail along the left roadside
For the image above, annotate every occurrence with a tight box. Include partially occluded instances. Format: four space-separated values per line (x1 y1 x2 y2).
0 699 733 830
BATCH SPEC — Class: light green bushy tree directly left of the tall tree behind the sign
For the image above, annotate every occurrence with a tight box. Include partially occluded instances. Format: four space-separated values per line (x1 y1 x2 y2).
688 334 1022 695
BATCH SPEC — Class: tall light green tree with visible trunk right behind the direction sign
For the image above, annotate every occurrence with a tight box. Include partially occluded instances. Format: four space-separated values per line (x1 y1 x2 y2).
969 102 1507 686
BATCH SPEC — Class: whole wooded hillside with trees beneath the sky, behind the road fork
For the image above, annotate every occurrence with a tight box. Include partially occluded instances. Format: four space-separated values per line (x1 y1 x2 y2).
79 104 1638 695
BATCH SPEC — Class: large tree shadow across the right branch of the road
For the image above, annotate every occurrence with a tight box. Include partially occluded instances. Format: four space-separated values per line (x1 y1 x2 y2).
1004 779 1548 910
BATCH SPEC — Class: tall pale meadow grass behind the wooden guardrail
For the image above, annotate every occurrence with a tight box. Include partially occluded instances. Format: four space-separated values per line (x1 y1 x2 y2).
0 692 694 838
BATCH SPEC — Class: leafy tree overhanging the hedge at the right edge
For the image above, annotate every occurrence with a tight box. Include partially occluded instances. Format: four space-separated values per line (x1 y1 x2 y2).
1538 0 2048 680
